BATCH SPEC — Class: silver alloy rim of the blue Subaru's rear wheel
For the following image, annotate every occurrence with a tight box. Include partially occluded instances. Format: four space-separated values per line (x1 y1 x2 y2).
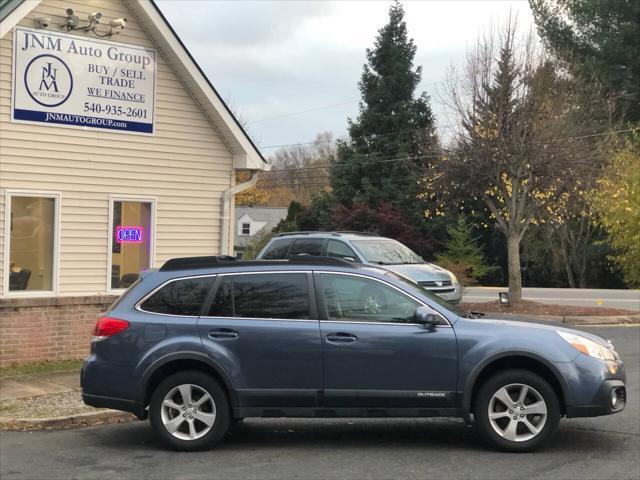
160 383 216 440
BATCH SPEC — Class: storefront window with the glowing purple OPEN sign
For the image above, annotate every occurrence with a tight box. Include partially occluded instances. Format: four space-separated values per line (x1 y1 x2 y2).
111 200 153 288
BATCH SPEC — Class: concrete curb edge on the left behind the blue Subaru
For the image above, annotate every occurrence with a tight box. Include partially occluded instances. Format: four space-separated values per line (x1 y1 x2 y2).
0 410 137 431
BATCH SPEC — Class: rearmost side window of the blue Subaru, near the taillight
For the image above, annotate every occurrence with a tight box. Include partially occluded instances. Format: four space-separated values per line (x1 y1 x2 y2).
140 277 215 317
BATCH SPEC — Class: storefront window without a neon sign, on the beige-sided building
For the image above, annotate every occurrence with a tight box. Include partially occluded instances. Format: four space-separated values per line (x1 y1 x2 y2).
9 195 56 291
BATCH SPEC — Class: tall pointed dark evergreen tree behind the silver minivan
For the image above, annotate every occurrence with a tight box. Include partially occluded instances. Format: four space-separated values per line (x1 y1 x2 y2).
331 3 438 216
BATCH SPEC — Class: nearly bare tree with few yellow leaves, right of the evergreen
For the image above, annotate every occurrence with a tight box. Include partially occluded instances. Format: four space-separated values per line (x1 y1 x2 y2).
432 18 604 301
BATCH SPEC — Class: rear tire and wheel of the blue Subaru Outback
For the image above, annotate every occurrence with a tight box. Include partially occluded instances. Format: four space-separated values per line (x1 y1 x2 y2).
149 371 231 451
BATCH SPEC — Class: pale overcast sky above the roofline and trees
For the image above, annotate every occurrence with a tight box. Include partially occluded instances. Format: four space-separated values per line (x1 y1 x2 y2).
157 0 533 156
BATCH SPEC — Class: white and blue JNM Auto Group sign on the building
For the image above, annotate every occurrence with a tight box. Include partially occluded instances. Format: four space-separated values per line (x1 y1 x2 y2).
11 27 156 134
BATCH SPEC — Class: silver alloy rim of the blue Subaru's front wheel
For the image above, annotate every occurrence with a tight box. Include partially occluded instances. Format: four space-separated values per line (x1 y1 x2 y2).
488 383 547 442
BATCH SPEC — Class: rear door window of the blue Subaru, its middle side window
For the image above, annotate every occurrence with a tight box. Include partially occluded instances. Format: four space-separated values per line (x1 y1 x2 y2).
208 273 311 320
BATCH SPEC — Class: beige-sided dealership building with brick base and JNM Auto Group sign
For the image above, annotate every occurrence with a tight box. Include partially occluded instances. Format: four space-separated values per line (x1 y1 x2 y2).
0 0 268 366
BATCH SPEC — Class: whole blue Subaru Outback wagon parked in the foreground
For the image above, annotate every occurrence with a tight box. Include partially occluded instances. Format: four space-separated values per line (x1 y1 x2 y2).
82 256 626 452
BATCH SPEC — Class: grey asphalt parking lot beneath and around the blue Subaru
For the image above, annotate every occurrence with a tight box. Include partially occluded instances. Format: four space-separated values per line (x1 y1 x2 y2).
0 326 640 480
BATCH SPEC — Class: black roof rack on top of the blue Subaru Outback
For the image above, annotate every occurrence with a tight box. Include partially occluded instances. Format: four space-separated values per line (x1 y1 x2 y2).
160 255 357 272
